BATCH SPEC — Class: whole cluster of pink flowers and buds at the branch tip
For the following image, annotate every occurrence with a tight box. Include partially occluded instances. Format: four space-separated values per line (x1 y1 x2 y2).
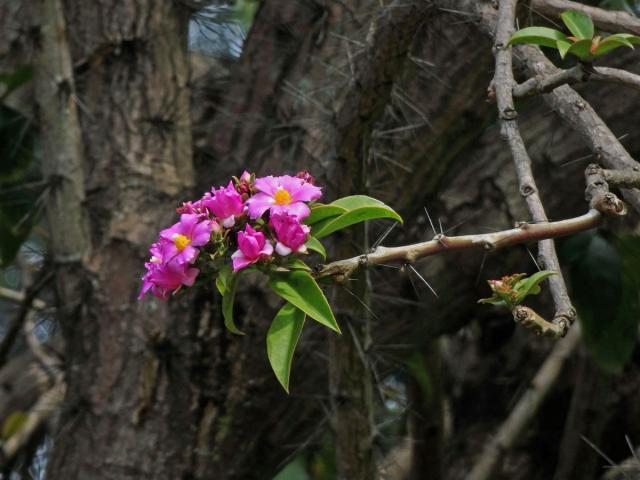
140 172 322 299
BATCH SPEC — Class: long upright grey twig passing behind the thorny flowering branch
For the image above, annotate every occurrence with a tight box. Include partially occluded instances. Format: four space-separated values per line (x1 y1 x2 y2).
493 0 576 336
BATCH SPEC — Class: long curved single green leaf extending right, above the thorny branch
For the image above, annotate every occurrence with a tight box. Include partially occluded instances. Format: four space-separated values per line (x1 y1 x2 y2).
312 195 402 238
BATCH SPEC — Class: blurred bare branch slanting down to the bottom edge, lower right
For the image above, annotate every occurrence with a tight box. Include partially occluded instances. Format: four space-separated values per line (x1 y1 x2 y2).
467 322 580 480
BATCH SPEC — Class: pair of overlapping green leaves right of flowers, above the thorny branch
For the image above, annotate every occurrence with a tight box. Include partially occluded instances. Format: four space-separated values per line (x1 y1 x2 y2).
306 195 402 238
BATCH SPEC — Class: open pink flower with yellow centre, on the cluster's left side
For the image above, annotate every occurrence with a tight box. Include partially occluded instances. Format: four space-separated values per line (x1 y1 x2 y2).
160 213 217 263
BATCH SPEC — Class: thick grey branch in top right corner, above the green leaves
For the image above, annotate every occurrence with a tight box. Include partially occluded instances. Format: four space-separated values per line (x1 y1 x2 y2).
531 0 640 35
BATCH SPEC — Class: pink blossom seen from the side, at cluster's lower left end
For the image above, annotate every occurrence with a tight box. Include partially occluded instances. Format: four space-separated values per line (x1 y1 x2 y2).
138 240 199 300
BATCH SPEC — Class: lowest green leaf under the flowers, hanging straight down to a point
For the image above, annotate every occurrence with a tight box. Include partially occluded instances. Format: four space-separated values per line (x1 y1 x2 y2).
267 302 305 393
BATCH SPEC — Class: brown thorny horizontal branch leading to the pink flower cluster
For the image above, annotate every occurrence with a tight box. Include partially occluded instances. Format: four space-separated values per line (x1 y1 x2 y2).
315 205 623 282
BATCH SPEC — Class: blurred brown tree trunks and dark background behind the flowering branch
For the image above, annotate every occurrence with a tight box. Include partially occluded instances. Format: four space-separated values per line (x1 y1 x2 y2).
0 0 640 480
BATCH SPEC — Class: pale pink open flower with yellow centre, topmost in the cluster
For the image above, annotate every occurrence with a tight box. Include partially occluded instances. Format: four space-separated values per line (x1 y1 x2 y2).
247 175 322 219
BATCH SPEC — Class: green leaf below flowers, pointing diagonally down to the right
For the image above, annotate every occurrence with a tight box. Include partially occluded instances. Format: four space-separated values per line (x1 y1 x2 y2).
269 270 340 333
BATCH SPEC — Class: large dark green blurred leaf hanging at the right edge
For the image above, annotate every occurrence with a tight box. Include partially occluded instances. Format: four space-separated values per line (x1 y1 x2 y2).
562 232 640 372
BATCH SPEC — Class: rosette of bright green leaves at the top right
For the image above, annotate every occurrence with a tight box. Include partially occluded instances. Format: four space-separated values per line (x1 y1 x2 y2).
509 10 640 62
